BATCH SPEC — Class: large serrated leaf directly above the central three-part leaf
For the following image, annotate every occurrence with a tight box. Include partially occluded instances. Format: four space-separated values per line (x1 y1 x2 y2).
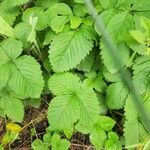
49 25 93 72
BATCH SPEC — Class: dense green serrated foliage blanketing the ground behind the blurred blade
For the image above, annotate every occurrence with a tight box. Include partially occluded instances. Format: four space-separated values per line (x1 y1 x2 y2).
0 0 150 150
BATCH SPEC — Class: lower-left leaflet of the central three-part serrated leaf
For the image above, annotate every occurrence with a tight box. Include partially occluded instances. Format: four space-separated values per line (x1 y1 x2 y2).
48 95 80 129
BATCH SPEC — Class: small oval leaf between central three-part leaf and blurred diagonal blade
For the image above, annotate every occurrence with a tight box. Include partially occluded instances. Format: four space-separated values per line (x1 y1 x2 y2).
106 82 128 109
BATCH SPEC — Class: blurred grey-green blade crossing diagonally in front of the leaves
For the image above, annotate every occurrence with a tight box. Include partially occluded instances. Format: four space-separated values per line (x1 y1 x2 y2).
85 0 150 133
